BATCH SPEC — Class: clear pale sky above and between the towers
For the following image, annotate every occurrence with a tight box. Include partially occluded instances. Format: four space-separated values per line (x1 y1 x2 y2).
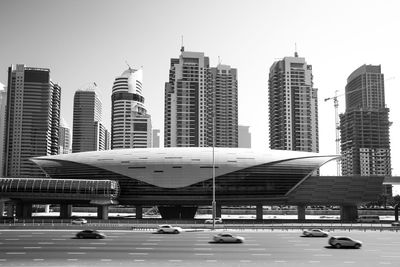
0 0 400 191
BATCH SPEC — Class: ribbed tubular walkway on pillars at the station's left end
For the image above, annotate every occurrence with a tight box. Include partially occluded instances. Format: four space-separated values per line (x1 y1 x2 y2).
0 178 120 219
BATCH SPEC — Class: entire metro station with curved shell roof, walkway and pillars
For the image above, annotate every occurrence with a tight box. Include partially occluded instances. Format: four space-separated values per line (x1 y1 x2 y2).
0 147 395 221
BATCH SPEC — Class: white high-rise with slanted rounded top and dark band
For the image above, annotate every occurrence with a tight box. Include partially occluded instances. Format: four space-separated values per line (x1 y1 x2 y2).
111 68 152 149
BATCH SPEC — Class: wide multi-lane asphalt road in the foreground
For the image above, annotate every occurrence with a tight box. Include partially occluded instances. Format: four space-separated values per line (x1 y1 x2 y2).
0 230 400 267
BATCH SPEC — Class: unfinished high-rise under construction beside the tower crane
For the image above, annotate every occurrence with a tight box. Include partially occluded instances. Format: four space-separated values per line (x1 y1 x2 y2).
340 65 392 195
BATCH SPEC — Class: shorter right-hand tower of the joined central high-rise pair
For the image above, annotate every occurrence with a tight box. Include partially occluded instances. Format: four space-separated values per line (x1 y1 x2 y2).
208 64 239 147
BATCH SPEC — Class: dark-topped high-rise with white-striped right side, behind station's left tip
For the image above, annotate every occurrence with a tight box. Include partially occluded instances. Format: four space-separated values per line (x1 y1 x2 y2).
4 64 61 177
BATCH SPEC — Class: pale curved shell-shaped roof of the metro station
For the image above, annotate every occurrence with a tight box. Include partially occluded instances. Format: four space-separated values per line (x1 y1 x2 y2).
32 147 338 188
